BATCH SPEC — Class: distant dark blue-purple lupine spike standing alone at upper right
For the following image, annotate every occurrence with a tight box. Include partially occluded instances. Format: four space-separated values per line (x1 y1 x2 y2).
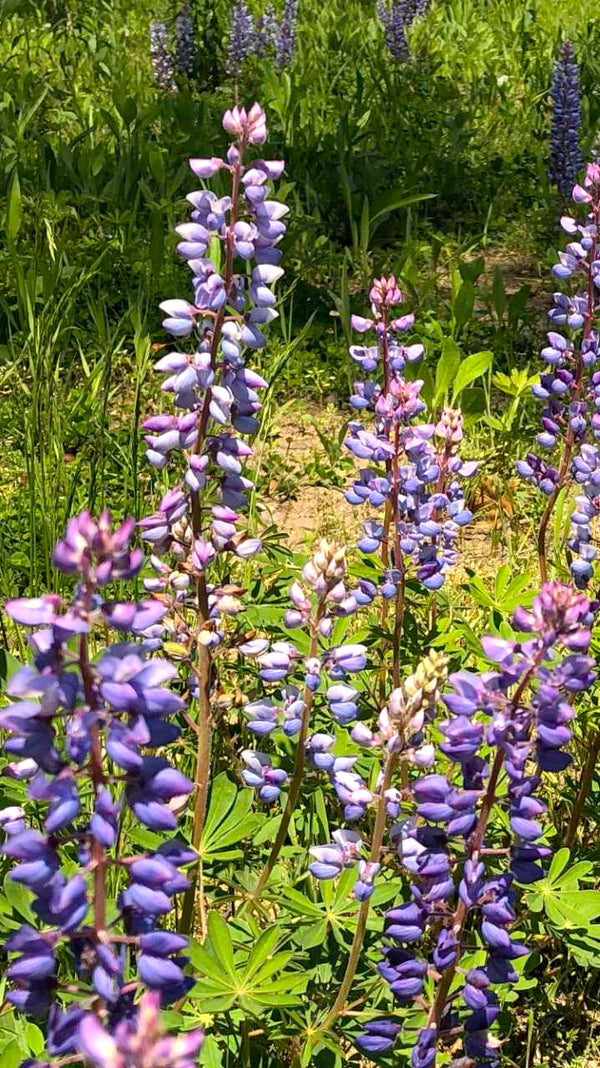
548 41 583 198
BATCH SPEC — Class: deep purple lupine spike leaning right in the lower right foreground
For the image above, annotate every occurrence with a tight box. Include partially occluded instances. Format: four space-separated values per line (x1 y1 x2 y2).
360 583 595 1068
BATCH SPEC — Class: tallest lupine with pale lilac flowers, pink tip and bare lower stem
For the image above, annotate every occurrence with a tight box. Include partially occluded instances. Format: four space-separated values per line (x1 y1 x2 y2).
140 104 287 922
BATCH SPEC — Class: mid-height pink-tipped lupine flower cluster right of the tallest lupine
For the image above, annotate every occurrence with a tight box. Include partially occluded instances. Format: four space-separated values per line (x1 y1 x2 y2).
345 276 476 615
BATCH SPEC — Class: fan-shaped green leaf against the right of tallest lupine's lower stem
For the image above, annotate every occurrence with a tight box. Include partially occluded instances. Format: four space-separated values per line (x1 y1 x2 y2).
199 772 267 861
